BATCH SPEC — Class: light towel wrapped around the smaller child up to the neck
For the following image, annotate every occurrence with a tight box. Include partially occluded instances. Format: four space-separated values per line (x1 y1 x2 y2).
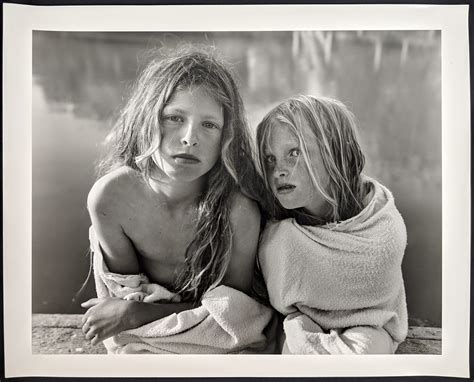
259 178 408 354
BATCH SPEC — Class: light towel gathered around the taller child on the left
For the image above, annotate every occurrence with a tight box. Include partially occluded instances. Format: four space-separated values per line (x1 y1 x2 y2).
89 227 274 354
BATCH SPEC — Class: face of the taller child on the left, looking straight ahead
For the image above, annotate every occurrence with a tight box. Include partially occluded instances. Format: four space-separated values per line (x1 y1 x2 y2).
155 87 224 182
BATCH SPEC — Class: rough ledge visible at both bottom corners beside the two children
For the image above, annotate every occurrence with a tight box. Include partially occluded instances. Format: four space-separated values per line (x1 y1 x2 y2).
32 314 441 354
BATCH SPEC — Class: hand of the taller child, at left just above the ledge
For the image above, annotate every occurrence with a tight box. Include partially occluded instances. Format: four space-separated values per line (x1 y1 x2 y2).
81 297 132 345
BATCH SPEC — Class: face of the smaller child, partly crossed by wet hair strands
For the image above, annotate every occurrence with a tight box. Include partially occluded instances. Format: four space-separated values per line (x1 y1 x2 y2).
263 122 329 217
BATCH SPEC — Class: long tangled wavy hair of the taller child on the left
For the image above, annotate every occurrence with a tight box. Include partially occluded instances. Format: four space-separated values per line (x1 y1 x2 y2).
99 47 264 302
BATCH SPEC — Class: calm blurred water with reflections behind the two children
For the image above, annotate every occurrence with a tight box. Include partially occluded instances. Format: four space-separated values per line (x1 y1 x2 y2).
32 31 441 325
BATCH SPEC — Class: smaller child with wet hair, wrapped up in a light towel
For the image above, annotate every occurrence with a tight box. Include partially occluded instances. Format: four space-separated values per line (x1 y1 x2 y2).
257 95 407 354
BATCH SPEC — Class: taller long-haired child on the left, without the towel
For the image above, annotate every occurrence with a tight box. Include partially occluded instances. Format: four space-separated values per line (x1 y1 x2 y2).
82 48 268 352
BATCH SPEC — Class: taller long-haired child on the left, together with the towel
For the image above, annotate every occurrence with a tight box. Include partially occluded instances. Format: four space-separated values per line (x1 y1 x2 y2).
82 49 272 353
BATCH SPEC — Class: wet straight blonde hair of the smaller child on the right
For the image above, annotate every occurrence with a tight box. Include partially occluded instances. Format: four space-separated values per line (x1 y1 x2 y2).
257 95 367 225
